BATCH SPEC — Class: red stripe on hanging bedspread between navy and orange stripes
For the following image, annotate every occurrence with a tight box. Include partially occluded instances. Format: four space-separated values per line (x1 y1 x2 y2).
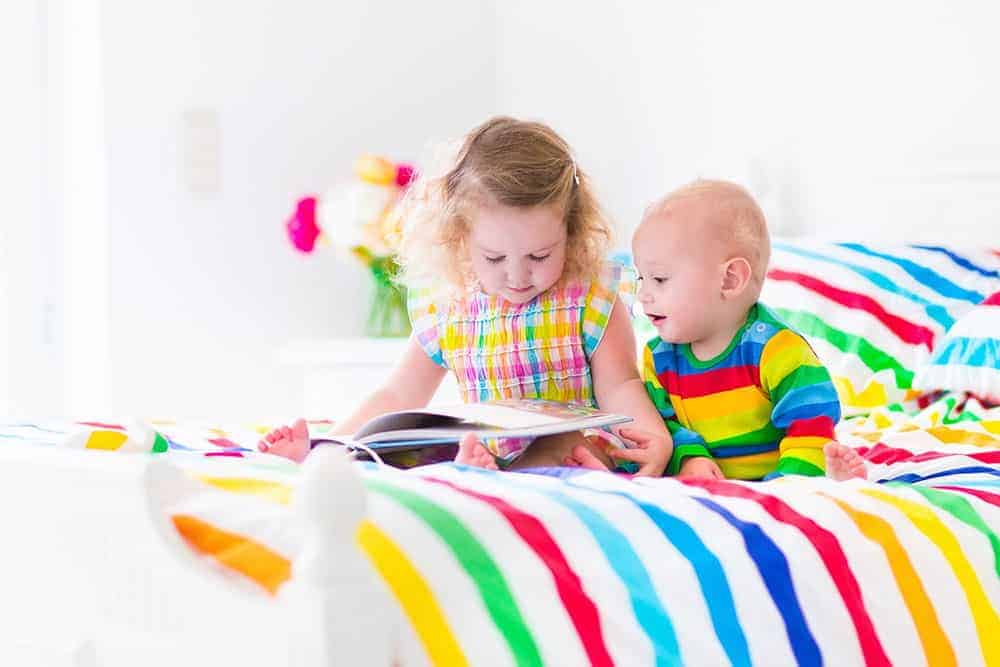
681 479 891 665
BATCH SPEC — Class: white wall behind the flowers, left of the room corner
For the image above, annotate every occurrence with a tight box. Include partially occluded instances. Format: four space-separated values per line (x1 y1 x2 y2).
102 0 495 418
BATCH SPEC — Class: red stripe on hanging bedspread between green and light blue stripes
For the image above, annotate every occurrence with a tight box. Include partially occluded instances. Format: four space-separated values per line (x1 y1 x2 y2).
423 477 614 667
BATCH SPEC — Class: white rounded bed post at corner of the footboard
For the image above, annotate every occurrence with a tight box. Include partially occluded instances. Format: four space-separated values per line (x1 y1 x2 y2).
280 447 401 667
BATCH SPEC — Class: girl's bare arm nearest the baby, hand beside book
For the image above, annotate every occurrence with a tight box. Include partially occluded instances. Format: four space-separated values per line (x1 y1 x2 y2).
590 301 673 476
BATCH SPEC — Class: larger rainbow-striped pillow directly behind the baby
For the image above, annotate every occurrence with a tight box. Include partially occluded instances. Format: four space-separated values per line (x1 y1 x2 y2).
761 239 1000 415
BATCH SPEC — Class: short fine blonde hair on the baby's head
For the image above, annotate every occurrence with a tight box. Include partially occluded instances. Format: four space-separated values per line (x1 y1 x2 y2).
643 179 771 291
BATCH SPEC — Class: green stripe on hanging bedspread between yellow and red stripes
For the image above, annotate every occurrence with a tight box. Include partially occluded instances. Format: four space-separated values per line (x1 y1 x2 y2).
365 479 542 665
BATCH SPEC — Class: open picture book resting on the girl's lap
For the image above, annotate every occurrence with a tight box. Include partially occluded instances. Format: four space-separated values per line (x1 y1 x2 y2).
312 399 632 458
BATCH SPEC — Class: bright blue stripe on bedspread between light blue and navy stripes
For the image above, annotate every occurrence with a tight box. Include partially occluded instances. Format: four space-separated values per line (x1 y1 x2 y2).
570 482 751 666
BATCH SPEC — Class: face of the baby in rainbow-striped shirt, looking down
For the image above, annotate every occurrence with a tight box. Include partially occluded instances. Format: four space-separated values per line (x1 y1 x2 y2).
632 201 726 343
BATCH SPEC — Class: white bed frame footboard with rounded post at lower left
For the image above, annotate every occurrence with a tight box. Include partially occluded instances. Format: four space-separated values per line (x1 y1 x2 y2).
0 443 402 667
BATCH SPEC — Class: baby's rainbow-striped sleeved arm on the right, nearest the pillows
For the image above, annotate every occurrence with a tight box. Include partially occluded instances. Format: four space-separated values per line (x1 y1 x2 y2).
760 329 840 479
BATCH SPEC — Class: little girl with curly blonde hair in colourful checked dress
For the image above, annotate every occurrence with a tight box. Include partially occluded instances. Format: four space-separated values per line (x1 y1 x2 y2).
260 117 672 476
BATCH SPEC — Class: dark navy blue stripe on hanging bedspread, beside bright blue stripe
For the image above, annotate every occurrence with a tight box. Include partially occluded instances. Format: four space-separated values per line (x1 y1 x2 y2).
692 497 823 665
